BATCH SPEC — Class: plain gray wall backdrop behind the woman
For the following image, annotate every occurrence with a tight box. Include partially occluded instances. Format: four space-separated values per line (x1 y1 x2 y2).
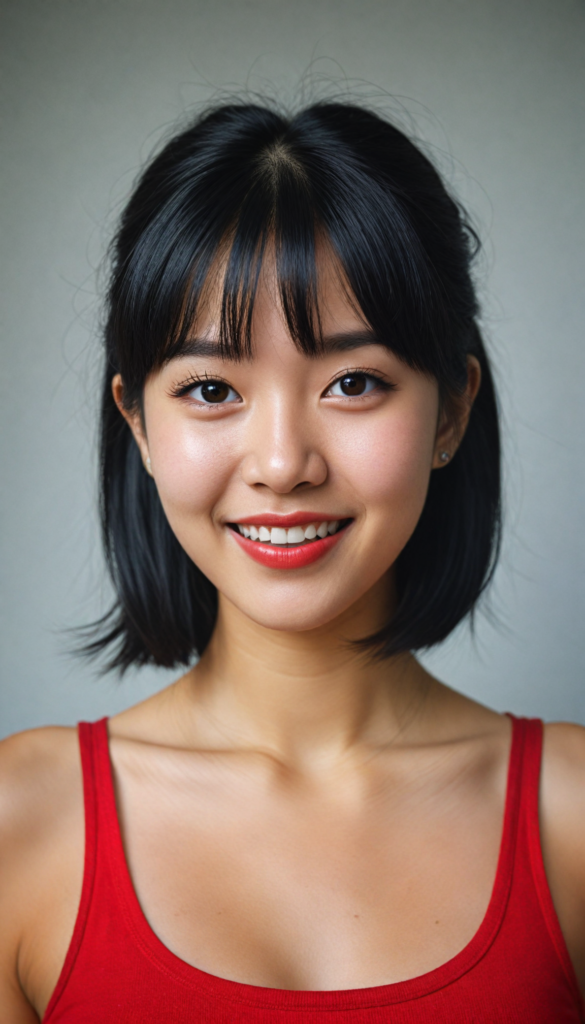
0 0 585 734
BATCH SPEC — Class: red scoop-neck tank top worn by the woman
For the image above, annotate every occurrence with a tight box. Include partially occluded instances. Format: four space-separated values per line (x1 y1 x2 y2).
43 719 585 1024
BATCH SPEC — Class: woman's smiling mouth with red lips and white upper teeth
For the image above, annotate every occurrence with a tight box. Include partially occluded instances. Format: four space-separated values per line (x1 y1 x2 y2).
228 513 353 569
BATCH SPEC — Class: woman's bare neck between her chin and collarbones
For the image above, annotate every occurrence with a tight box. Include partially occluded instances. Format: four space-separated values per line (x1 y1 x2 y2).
184 588 431 767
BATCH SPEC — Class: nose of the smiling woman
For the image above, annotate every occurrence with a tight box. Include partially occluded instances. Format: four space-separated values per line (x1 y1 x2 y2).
242 396 327 495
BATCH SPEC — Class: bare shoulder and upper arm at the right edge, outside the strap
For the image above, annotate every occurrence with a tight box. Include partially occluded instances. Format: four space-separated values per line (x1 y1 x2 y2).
540 723 585 991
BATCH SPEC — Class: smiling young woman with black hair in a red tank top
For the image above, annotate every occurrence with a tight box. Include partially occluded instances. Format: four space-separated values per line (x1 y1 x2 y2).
0 103 585 1024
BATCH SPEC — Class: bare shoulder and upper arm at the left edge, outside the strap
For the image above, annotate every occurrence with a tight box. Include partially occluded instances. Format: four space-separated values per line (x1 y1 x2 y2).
0 729 84 1024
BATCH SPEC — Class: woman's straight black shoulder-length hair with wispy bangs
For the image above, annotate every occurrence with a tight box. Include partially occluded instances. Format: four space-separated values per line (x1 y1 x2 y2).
84 96 500 671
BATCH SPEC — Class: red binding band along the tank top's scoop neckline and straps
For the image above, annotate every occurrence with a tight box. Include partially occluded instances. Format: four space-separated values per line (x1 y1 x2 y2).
95 715 526 1012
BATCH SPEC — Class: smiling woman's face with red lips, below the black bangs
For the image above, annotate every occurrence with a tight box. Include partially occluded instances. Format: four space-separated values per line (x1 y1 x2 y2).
114 257 445 631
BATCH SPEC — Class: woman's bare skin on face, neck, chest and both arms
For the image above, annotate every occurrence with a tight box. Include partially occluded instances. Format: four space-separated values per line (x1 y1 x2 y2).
0 255 585 1024
